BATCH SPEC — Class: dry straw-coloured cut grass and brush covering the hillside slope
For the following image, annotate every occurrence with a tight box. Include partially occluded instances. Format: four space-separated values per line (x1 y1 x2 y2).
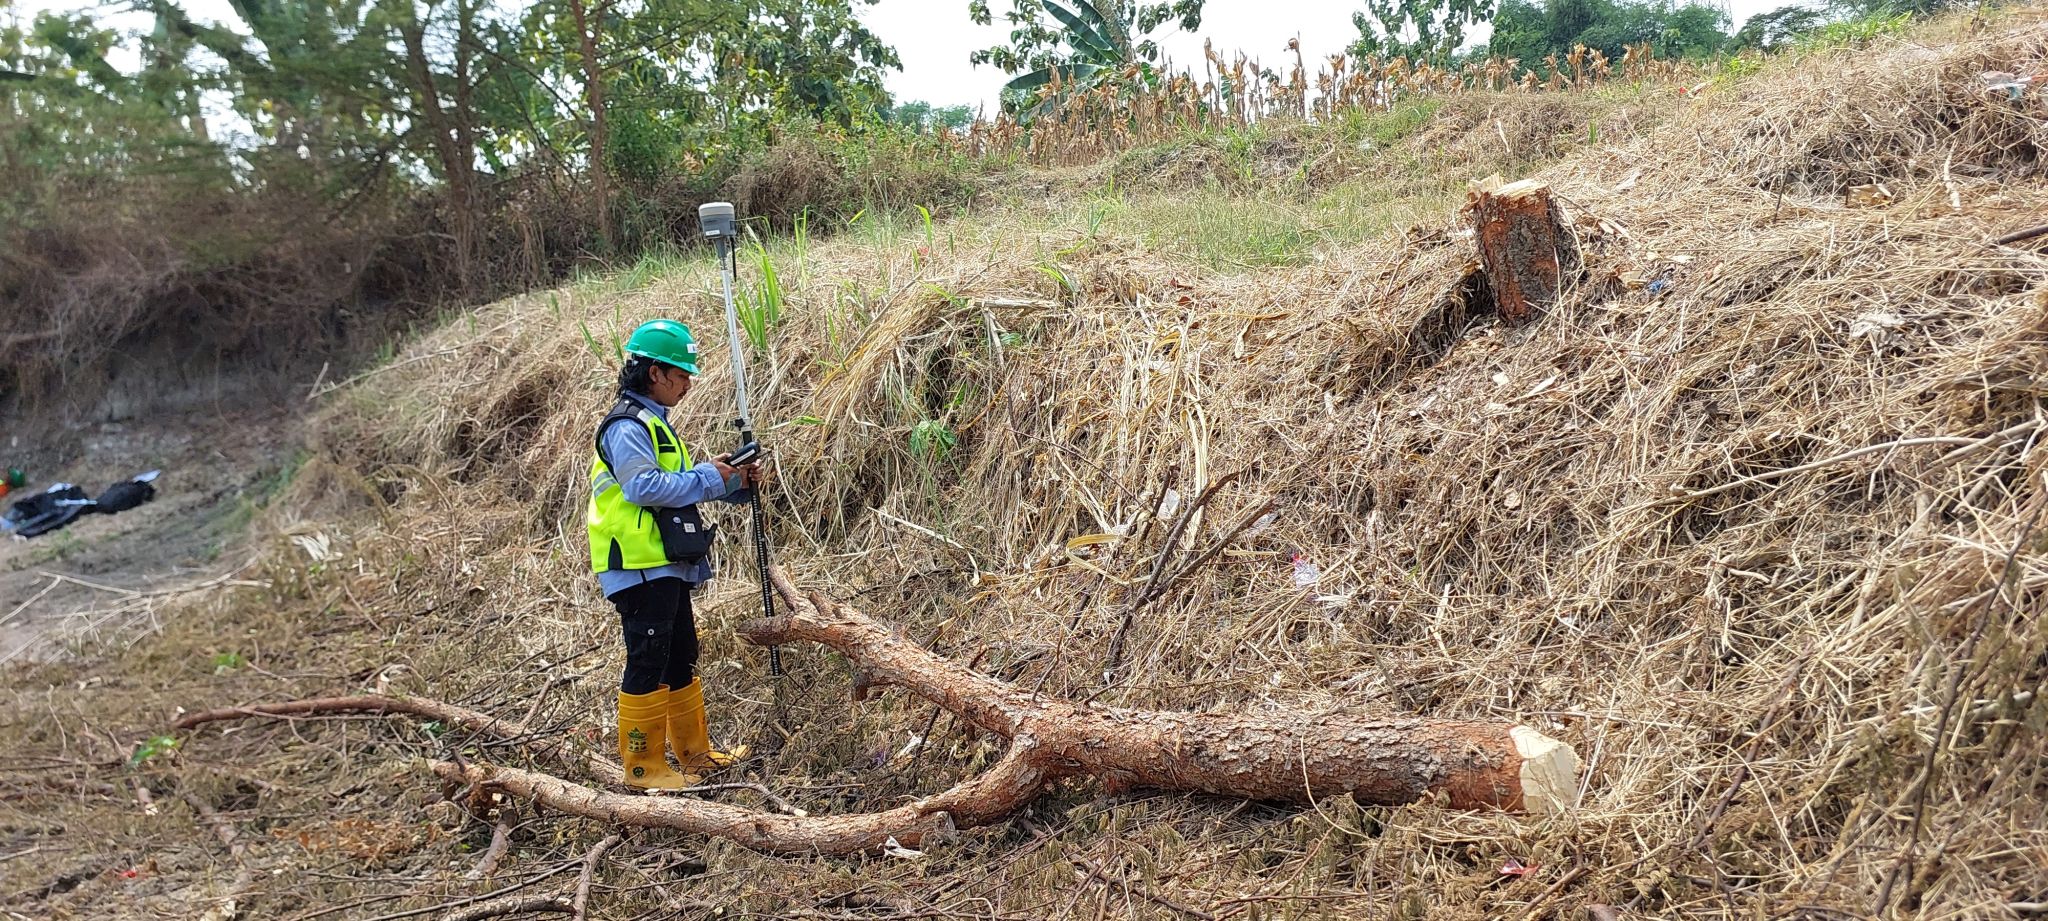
10 14 2048 919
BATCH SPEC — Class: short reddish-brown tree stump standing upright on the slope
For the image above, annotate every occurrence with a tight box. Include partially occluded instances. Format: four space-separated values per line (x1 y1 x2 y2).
1464 178 1579 323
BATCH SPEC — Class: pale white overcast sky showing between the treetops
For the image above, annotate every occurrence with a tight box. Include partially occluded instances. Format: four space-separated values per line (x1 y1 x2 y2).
16 0 1788 111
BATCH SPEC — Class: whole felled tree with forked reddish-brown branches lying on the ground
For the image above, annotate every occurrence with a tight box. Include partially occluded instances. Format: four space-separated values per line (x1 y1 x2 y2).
176 569 1579 853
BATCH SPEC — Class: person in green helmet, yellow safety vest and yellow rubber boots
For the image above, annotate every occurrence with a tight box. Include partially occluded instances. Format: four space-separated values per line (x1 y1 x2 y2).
586 319 762 790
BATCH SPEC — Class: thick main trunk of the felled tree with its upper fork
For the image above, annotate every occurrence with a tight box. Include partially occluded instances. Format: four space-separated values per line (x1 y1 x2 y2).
739 569 1579 827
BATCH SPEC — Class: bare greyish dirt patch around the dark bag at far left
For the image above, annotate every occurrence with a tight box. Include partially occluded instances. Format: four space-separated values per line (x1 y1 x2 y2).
0 403 299 665
